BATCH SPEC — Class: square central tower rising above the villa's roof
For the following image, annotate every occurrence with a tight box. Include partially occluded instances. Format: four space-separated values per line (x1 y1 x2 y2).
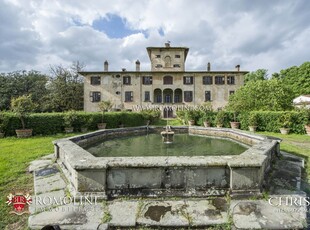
146 42 189 72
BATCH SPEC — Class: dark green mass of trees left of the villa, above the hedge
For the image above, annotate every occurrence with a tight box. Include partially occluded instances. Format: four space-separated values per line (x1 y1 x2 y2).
0 62 83 112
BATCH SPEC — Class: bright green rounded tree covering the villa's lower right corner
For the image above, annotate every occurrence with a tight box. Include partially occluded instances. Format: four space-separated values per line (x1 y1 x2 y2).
227 79 294 112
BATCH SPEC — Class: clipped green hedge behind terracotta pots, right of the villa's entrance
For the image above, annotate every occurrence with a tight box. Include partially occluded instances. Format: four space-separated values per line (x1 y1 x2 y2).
177 110 308 134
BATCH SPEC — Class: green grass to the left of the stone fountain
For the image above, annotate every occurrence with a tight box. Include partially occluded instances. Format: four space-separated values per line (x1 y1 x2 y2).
0 134 78 229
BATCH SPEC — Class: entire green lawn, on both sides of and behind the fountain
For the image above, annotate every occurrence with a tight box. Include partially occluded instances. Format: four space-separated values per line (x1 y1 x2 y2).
0 130 310 230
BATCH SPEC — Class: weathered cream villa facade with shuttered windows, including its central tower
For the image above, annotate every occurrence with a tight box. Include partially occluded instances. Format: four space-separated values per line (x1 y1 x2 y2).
80 43 248 117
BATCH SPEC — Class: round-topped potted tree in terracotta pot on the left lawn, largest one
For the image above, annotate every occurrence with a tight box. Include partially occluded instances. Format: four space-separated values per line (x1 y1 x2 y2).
11 95 35 138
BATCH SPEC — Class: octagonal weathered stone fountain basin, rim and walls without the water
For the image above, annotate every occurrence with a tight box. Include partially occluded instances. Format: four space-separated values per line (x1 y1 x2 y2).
54 126 279 198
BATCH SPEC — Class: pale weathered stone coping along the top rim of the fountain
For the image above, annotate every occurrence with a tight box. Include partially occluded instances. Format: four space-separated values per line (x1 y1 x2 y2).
53 126 278 170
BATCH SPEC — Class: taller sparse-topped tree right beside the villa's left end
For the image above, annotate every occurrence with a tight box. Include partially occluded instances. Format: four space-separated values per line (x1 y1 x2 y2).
45 62 84 112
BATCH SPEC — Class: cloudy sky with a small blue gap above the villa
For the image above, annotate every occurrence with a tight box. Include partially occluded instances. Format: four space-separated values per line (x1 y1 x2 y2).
0 0 310 74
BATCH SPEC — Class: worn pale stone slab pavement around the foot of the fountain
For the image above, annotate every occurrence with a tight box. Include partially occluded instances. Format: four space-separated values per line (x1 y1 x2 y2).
29 153 307 230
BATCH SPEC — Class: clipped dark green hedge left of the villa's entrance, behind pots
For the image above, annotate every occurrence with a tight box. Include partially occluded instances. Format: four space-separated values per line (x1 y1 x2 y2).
2 112 159 136
